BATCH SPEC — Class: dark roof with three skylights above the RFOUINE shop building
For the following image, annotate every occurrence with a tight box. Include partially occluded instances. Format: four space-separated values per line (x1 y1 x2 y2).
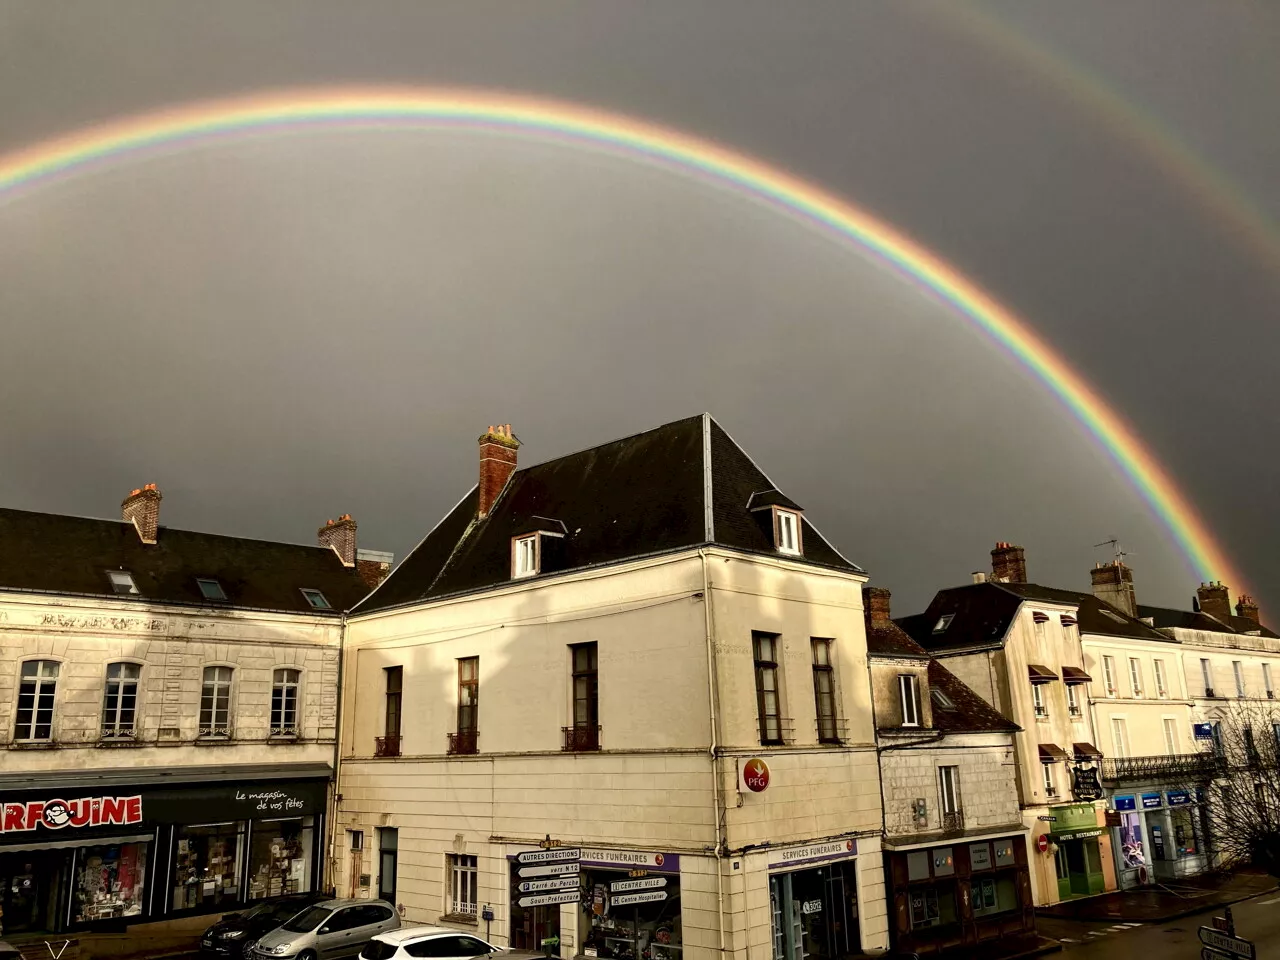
0 508 369 613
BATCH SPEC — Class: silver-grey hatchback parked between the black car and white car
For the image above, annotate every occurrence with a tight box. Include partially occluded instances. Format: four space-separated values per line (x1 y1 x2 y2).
252 900 399 960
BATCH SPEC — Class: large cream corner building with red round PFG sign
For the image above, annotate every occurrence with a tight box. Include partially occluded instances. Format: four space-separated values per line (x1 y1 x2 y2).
334 415 888 960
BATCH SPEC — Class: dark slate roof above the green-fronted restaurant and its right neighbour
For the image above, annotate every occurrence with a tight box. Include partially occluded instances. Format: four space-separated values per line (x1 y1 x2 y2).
896 580 1172 652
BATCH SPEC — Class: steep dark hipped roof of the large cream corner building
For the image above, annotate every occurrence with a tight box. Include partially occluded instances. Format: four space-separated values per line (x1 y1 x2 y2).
357 415 861 613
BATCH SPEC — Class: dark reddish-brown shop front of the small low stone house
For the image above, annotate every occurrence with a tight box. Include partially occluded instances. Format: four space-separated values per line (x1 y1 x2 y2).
884 833 1036 954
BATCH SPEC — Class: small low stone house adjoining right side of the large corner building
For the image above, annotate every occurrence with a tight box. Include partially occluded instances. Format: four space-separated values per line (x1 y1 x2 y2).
864 588 1036 955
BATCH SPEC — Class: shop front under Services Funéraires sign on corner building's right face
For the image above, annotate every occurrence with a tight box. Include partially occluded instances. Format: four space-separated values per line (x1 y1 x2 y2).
768 838 861 960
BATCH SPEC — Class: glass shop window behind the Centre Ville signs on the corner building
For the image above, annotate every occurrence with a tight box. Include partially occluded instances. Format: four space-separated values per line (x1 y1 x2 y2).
582 869 682 960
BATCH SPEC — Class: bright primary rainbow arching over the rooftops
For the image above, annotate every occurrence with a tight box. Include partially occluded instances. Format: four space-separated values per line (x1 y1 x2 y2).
0 87 1245 589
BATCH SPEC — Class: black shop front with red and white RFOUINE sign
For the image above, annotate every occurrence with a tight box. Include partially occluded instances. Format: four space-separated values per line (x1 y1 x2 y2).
0 777 329 936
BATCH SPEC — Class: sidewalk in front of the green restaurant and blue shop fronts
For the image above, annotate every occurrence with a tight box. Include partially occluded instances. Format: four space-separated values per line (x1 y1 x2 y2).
1036 870 1276 923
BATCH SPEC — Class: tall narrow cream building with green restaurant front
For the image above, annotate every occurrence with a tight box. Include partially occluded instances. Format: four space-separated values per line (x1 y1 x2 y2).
896 543 1116 905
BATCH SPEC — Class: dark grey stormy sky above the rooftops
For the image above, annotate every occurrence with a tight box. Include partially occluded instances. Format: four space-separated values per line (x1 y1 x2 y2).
0 0 1280 613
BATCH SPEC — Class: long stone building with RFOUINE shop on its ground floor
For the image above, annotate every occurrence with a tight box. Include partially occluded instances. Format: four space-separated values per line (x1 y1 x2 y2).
0 484 376 940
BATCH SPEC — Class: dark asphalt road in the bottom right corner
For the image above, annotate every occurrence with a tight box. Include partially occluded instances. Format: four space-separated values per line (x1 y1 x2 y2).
1036 892 1280 960
